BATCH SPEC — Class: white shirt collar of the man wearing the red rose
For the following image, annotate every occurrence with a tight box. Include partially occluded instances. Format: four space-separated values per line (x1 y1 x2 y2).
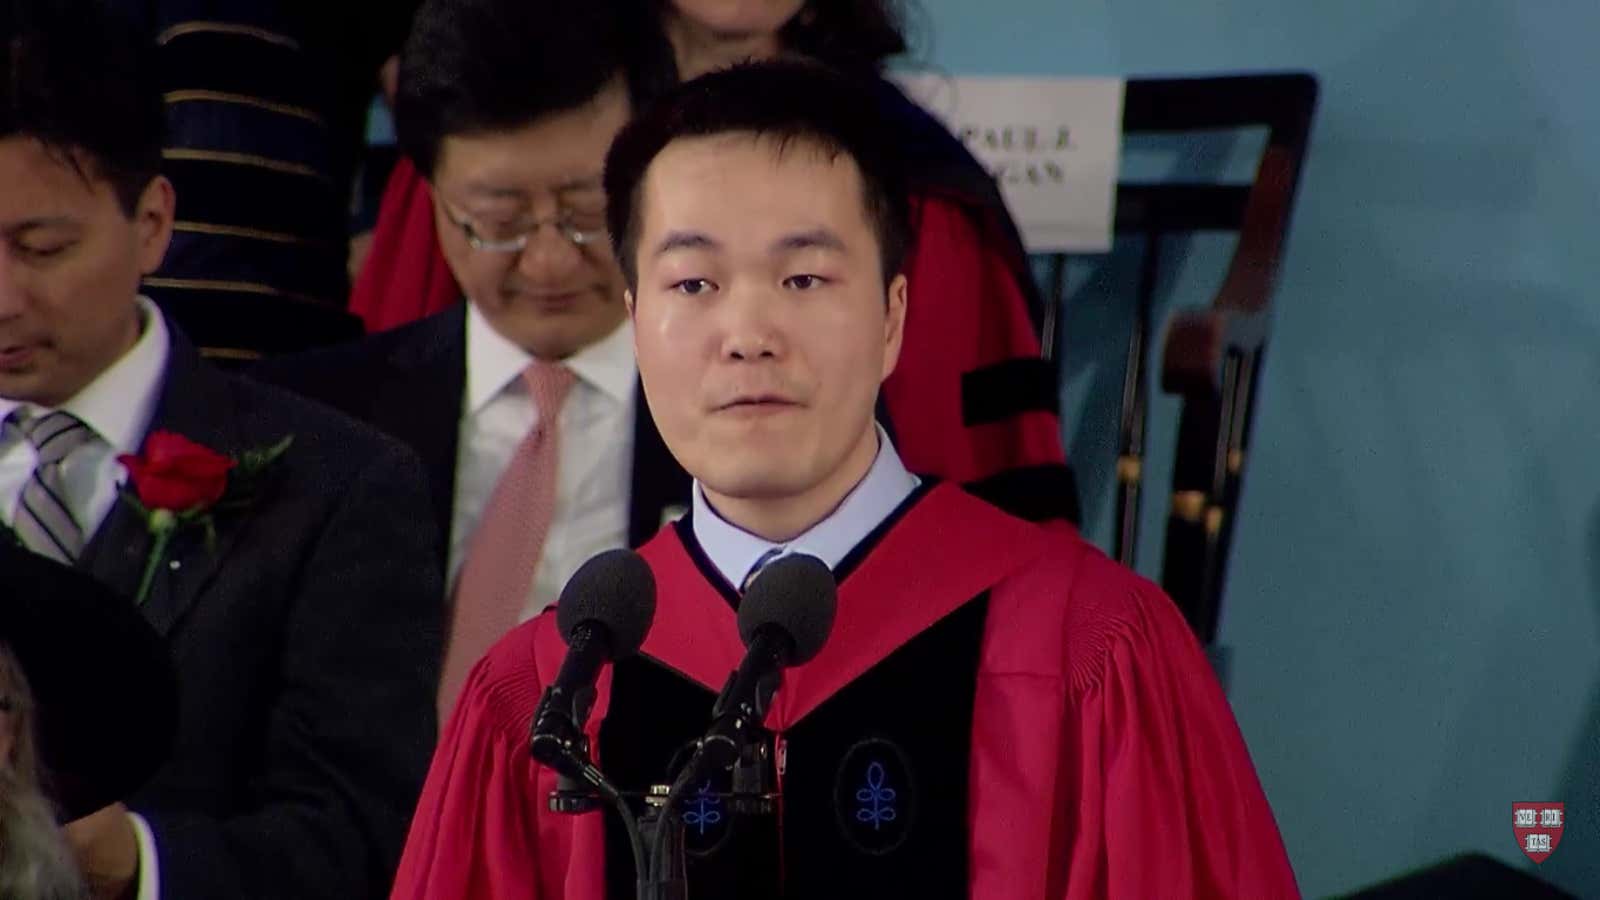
0 296 171 453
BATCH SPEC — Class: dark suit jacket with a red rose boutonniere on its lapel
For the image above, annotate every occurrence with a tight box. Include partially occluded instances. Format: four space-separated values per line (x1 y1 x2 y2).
82 330 443 900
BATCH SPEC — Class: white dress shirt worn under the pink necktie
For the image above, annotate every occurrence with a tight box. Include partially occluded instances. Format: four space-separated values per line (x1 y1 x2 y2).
450 303 638 620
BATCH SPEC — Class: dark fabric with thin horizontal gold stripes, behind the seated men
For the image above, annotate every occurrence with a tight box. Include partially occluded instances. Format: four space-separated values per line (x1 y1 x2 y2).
144 0 360 359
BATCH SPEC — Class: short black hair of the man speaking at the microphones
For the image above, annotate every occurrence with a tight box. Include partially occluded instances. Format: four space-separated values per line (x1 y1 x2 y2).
605 59 910 290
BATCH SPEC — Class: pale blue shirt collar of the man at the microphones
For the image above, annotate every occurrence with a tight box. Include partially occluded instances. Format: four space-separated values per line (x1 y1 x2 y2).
691 426 922 588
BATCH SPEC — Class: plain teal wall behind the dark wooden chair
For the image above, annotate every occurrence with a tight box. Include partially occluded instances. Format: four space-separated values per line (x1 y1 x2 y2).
912 0 1600 897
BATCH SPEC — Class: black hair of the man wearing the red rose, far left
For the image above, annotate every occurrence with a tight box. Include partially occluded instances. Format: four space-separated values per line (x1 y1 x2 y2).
0 0 166 216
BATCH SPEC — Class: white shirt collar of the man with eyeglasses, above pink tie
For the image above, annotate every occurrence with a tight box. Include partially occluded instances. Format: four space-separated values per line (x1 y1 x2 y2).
467 299 638 415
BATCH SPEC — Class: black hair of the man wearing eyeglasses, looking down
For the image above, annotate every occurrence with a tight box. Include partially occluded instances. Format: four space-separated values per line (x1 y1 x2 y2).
395 0 638 178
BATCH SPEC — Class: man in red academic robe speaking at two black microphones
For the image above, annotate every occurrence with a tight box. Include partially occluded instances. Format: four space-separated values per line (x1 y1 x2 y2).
394 64 1298 900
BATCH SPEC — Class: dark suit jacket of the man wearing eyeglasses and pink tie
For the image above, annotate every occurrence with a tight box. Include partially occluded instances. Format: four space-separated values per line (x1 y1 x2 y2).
250 303 691 565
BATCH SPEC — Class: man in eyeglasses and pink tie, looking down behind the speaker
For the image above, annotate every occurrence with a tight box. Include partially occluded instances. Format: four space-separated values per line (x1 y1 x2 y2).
262 0 690 714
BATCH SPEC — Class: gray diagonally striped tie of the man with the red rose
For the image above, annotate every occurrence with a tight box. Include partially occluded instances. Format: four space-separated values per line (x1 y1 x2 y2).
5 408 94 564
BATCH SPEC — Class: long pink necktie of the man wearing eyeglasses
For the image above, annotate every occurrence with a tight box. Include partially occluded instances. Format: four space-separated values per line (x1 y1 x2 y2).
438 360 576 714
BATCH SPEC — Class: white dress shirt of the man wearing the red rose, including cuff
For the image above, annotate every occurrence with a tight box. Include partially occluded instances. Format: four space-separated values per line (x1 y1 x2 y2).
0 296 171 900
